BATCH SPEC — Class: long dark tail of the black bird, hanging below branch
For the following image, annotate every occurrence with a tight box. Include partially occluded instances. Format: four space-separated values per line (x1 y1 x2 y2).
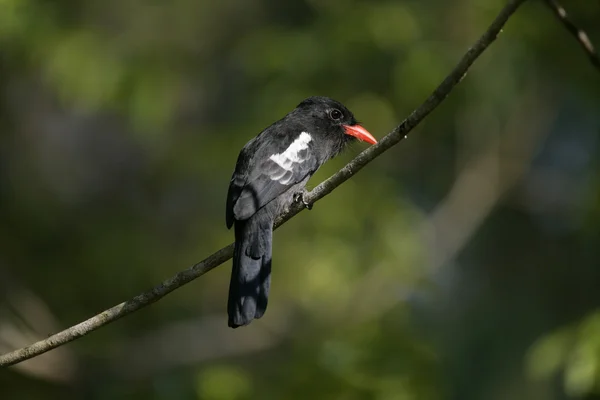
227 211 273 328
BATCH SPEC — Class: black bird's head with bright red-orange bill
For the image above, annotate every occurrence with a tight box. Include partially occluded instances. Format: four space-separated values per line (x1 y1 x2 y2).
296 96 377 144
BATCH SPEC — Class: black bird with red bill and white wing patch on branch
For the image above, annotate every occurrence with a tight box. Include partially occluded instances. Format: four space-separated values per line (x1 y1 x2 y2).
226 97 377 328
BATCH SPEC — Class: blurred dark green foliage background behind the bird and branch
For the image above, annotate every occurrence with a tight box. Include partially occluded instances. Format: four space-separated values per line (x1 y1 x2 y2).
0 0 600 400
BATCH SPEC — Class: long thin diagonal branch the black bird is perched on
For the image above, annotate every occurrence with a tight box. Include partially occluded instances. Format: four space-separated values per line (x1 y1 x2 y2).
0 0 525 366
